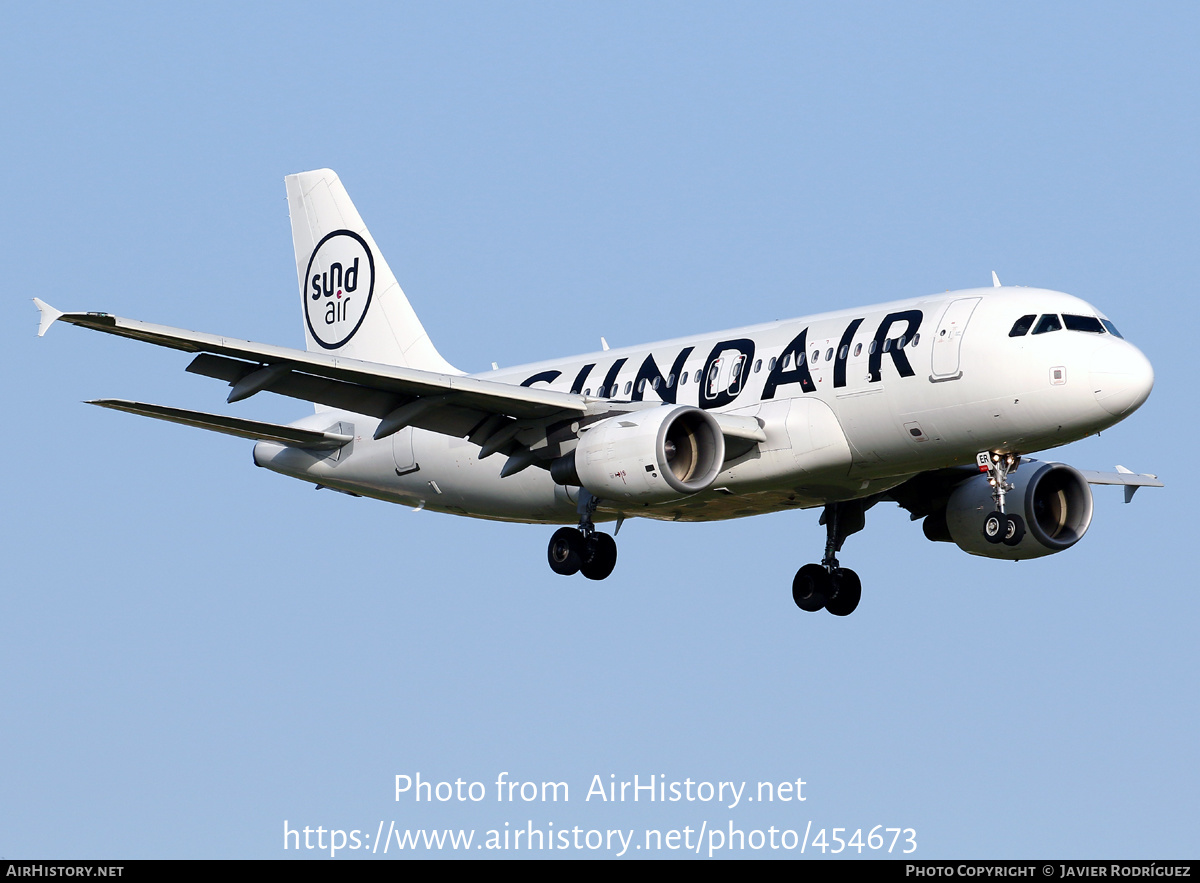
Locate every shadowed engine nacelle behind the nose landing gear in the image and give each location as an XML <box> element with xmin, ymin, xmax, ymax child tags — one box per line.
<box><xmin>925</xmin><ymin>461</ymin><xmax>1092</xmax><ymax>560</ymax></box>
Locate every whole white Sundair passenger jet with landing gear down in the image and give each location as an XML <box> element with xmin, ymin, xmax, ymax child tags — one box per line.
<box><xmin>35</xmin><ymin>169</ymin><xmax>1162</xmax><ymax>615</ymax></box>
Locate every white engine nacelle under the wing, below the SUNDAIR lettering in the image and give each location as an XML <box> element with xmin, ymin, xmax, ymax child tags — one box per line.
<box><xmin>551</xmin><ymin>404</ymin><xmax>725</xmax><ymax>504</ymax></box>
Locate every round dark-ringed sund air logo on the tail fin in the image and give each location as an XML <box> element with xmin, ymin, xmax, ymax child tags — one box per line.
<box><xmin>302</xmin><ymin>230</ymin><xmax>374</xmax><ymax>349</ymax></box>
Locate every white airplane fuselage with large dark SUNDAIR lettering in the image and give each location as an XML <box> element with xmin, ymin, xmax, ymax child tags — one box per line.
<box><xmin>254</xmin><ymin>288</ymin><xmax>1153</xmax><ymax>523</ymax></box>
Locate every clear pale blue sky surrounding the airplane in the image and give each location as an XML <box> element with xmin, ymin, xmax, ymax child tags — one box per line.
<box><xmin>0</xmin><ymin>4</ymin><xmax>1200</xmax><ymax>858</ymax></box>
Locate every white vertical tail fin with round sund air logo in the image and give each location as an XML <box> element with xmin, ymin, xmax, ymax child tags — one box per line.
<box><xmin>283</xmin><ymin>169</ymin><xmax>462</xmax><ymax>374</ymax></box>
